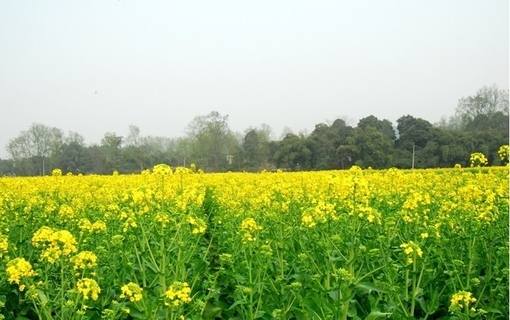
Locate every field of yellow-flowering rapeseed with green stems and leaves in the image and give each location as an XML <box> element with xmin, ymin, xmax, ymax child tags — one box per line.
<box><xmin>0</xmin><ymin>165</ymin><xmax>509</xmax><ymax>320</ymax></box>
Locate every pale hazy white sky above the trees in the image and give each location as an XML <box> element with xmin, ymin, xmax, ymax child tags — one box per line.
<box><xmin>0</xmin><ymin>0</ymin><xmax>509</xmax><ymax>158</ymax></box>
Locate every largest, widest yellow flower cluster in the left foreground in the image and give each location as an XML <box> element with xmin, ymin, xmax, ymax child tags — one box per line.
<box><xmin>32</xmin><ymin>226</ymin><xmax>78</xmax><ymax>263</ymax></box>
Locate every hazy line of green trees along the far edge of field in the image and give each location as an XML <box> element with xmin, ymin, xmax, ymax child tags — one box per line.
<box><xmin>0</xmin><ymin>85</ymin><xmax>509</xmax><ymax>175</ymax></box>
